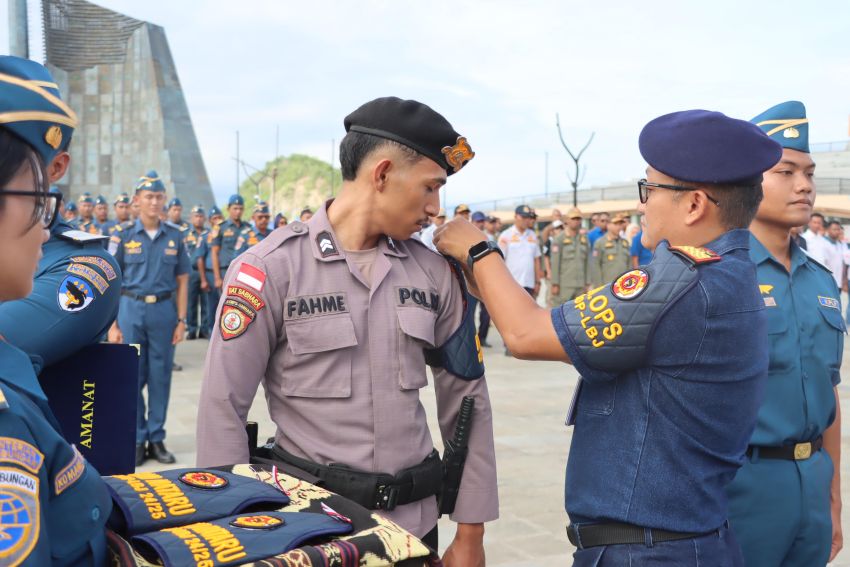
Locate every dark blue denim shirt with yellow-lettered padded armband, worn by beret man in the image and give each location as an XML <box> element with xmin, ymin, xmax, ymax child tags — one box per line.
<box><xmin>552</xmin><ymin>230</ymin><xmax>768</xmax><ymax>532</ymax></box>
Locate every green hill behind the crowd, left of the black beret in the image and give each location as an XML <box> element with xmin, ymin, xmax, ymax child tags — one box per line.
<box><xmin>239</xmin><ymin>154</ymin><xmax>342</xmax><ymax>220</ymax></box>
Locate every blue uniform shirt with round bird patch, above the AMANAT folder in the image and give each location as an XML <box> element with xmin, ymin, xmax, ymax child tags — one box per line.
<box><xmin>0</xmin><ymin>220</ymin><xmax>121</xmax><ymax>373</ymax></box>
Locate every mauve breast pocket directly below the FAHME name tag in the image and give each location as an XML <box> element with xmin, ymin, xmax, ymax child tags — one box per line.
<box><xmin>281</xmin><ymin>314</ymin><xmax>357</xmax><ymax>398</ymax></box>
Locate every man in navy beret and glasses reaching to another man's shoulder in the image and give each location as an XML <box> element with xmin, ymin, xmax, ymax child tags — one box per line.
<box><xmin>434</xmin><ymin>110</ymin><xmax>782</xmax><ymax>567</ymax></box>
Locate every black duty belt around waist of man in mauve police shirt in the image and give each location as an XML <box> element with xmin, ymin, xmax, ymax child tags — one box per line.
<box><xmin>272</xmin><ymin>445</ymin><xmax>443</xmax><ymax>511</ymax></box>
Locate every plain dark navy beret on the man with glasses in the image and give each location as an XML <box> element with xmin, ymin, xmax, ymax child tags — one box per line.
<box><xmin>639</xmin><ymin>110</ymin><xmax>782</xmax><ymax>184</ymax></box>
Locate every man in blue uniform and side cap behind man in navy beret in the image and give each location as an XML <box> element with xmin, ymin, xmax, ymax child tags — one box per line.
<box><xmin>728</xmin><ymin>101</ymin><xmax>845</xmax><ymax>567</ymax></box>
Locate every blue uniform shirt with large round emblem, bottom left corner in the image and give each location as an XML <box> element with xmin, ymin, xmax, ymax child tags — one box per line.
<box><xmin>0</xmin><ymin>341</ymin><xmax>112</xmax><ymax>567</ymax></box>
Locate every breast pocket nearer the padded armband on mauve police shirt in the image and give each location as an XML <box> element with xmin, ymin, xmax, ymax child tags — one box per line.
<box><xmin>396</xmin><ymin>307</ymin><xmax>437</xmax><ymax>390</ymax></box>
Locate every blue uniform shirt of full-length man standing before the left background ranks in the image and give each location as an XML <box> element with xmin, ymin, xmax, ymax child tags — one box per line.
<box><xmin>109</xmin><ymin>220</ymin><xmax>189</xmax><ymax>295</ymax></box>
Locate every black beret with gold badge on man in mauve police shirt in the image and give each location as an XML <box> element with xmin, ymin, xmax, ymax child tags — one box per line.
<box><xmin>344</xmin><ymin>96</ymin><xmax>475</xmax><ymax>175</ymax></box>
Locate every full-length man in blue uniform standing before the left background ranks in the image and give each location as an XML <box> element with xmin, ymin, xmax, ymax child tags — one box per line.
<box><xmin>109</xmin><ymin>171</ymin><xmax>189</xmax><ymax>466</ymax></box>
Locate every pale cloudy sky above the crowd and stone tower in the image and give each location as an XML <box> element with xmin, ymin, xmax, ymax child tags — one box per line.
<box><xmin>0</xmin><ymin>0</ymin><xmax>850</xmax><ymax>209</ymax></box>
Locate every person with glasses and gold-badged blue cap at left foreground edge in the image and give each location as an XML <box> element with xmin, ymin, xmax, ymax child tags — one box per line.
<box><xmin>0</xmin><ymin>58</ymin><xmax>112</xmax><ymax>566</ymax></box>
